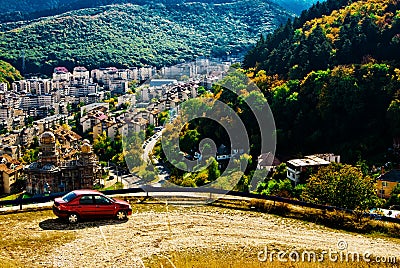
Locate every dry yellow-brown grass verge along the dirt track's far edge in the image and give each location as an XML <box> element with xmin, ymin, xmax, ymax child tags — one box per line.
<box><xmin>125</xmin><ymin>197</ymin><xmax>400</xmax><ymax>243</ymax></box>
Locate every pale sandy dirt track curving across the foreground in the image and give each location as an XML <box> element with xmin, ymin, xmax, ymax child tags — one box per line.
<box><xmin>31</xmin><ymin>207</ymin><xmax>400</xmax><ymax>267</ymax></box>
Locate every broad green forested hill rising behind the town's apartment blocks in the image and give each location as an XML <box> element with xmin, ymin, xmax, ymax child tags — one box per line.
<box><xmin>0</xmin><ymin>0</ymin><xmax>293</xmax><ymax>73</ymax></box>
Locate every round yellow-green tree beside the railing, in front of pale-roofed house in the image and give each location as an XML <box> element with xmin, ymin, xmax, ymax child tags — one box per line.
<box><xmin>302</xmin><ymin>163</ymin><xmax>379</xmax><ymax>210</ymax></box>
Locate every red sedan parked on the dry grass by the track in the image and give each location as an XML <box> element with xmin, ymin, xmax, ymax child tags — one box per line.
<box><xmin>53</xmin><ymin>190</ymin><xmax>132</xmax><ymax>223</ymax></box>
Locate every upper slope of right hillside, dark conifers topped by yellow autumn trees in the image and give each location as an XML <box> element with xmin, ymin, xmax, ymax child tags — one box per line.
<box><xmin>244</xmin><ymin>0</ymin><xmax>400</xmax><ymax>78</ymax></box>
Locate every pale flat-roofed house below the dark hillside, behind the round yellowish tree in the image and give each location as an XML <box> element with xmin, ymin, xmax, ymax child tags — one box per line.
<box><xmin>286</xmin><ymin>154</ymin><xmax>340</xmax><ymax>183</ymax></box>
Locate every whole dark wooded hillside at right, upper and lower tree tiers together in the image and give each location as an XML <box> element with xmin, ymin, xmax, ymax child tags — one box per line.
<box><xmin>244</xmin><ymin>0</ymin><xmax>400</xmax><ymax>162</ymax></box>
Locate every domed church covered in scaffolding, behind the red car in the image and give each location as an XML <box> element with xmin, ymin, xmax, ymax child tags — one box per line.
<box><xmin>24</xmin><ymin>131</ymin><xmax>102</xmax><ymax>194</ymax></box>
